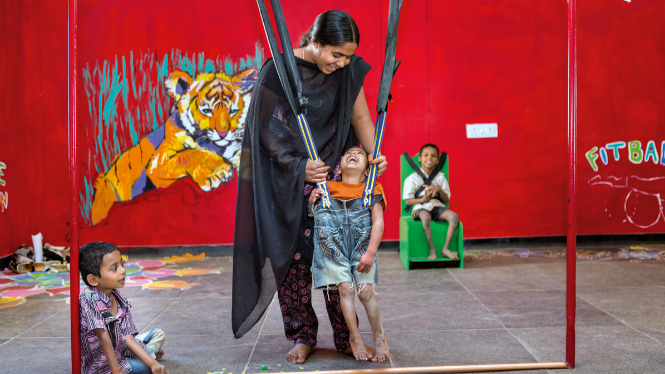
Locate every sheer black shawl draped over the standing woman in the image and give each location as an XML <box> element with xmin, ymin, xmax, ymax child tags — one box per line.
<box><xmin>232</xmin><ymin>56</ymin><xmax>371</xmax><ymax>338</ymax></box>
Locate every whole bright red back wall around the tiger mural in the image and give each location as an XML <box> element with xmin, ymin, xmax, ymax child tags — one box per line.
<box><xmin>0</xmin><ymin>0</ymin><xmax>665</xmax><ymax>252</ymax></box>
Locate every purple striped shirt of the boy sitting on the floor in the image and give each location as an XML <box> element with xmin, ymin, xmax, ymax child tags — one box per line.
<box><xmin>79</xmin><ymin>287</ymin><xmax>145</xmax><ymax>374</ymax></box>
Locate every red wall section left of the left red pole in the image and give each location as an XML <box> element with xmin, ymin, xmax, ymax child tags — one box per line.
<box><xmin>0</xmin><ymin>0</ymin><xmax>69</xmax><ymax>256</ymax></box>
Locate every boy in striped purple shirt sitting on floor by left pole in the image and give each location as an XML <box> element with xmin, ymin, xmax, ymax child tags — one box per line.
<box><xmin>79</xmin><ymin>242</ymin><xmax>169</xmax><ymax>374</ymax></box>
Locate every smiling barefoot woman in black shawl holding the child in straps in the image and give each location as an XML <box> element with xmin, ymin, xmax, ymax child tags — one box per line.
<box><xmin>232</xmin><ymin>10</ymin><xmax>387</xmax><ymax>363</ymax></box>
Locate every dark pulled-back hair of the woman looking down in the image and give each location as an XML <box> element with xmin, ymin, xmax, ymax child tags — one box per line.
<box><xmin>300</xmin><ymin>10</ymin><xmax>360</xmax><ymax>47</ymax></box>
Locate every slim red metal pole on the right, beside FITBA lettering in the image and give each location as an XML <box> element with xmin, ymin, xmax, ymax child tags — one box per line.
<box><xmin>566</xmin><ymin>0</ymin><xmax>577</xmax><ymax>369</ymax></box>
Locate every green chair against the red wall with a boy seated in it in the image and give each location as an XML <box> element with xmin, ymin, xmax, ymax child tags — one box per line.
<box><xmin>399</xmin><ymin>154</ymin><xmax>464</xmax><ymax>270</ymax></box>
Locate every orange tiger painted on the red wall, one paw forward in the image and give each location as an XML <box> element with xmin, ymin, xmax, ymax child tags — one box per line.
<box><xmin>91</xmin><ymin>68</ymin><xmax>258</xmax><ymax>225</ymax></box>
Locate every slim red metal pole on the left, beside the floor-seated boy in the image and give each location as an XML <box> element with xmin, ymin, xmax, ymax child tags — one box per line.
<box><xmin>68</xmin><ymin>0</ymin><xmax>81</xmax><ymax>374</ymax></box>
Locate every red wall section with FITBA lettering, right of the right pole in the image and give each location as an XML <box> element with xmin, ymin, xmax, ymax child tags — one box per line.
<box><xmin>578</xmin><ymin>0</ymin><xmax>665</xmax><ymax>234</ymax></box>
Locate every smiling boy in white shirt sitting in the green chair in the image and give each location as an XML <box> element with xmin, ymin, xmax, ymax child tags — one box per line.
<box><xmin>402</xmin><ymin>144</ymin><xmax>459</xmax><ymax>260</ymax></box>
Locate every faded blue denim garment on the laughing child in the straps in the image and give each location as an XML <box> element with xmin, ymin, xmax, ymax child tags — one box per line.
<box><xmin>312</xmin><ymin>199</ymin><xmax>379</xmax><ymax>289</ymax></box>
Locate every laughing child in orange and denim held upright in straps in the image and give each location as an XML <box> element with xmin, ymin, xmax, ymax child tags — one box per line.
<box><xmin>309</xmin><ymin>147</ymin><xmax>390</xmax><ymax>362</ymax></box>
